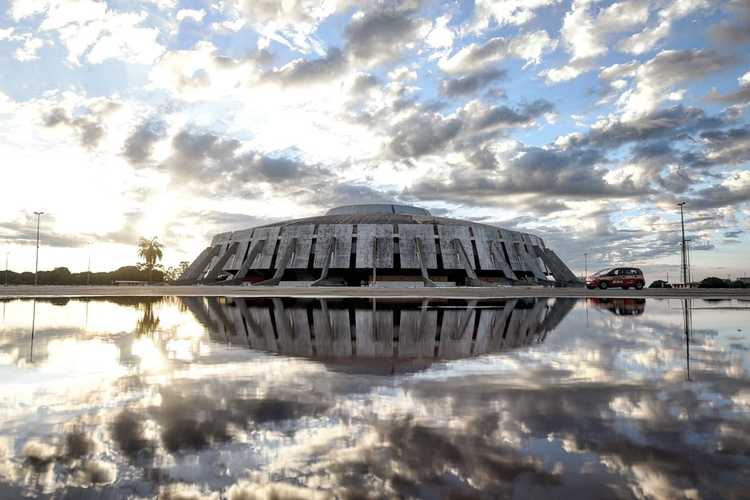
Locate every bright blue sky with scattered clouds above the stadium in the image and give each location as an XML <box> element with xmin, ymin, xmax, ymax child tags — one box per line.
<box><xmin>0</xmin><ymin>0</ymin><xmax>750</xmax><ymax>281</ymax></box>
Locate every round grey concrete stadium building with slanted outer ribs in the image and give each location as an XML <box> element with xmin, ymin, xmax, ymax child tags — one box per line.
<box><xmin>178</xmin><ymin>204</ymin><xmax>580</xmax><ymax>286</ymax></box>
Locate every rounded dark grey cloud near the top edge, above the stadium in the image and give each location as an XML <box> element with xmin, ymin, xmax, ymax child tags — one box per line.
<box><xmin>345</xmin><ymin>10</ymin><xmax>424</xmax><ymax>63</ymax></box>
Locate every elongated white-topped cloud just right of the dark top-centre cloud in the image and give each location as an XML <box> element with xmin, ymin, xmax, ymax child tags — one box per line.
<box><xmin>439</xmin><ymin>30</ymin><xmax>555</xmax><ymax>74</ymax></box>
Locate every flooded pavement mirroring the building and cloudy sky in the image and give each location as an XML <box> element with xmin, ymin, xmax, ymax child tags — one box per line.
<box><xmin>0</xmin><ymin>297</ymin><xmax>750</xmax><ymax>500</ymax></box>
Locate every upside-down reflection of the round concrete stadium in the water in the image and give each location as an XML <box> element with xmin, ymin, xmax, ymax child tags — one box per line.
<box><xmin>181</xmin><ymin>297</ymin><xmax>576</xmax><ymax>373</ymax></box>
